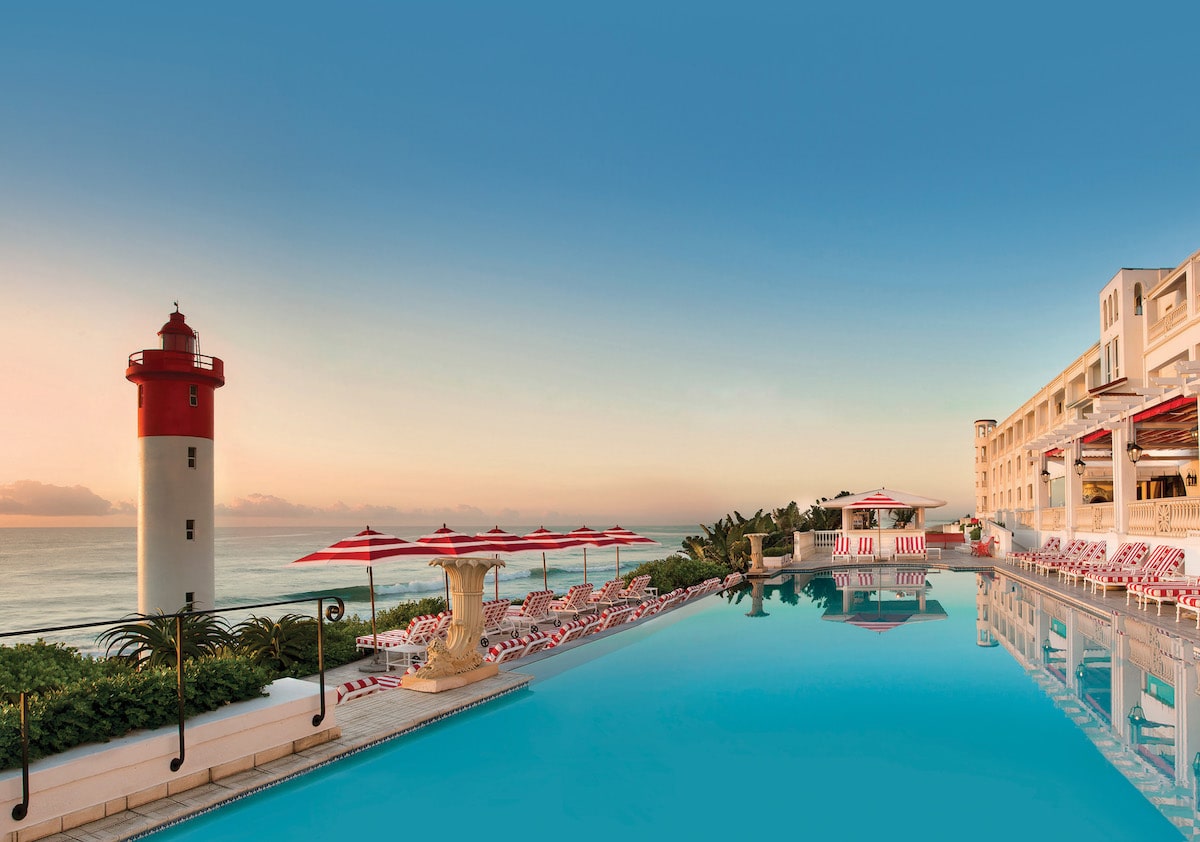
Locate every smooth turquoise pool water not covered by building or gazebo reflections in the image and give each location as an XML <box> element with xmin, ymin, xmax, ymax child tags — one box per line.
<box><xmin>149</xmin><ymin>573</ymin><xmax>1182</xmax><ymax>842</ymax></box>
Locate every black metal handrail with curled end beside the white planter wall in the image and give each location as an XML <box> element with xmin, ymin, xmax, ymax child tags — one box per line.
<box><xmin>0</xmin><ymin>596</ymin><xmax>346</xmax><ymax>822</ymax></box>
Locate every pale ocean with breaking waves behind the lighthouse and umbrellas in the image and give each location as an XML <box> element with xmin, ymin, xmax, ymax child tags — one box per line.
<box><xmin>0</xmin><ymin>524</ymin><xmax>701</xmax><ymax>652</ymax></box>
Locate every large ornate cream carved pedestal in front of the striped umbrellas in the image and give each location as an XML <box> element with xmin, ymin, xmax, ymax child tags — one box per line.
<box><xmin>401</xmin><ymin>555</ymin><xmax>504</xmax><ymax>693</ymax></box>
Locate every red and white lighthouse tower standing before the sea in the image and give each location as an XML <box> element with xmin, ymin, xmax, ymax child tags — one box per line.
<box><xmin>125</xmin><ymin>305</ymin><xmax>224</xmax><ymax>614</ymax></box>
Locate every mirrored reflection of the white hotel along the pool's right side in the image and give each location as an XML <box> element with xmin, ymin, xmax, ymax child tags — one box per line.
<box><xmin>976</xmin><ymin>571</ymin><xmax>1200</xmax><ymax>838</ymax></box>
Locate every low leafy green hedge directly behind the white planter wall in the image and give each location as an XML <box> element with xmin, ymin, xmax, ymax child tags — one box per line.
<box><xmin>0</xmin><ymin>656</ymin><xmax>271</xmax><ymax>769</ymax></box>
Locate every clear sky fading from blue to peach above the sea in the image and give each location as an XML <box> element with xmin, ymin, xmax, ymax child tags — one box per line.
<box><xmin>0</xmin><ymin>0</ymin><xmax>1200</xmax><ymax>527</ymax></box>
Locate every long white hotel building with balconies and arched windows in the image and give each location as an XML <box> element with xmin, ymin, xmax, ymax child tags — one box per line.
<box><xmin>974</xmin><ymin>252</ymin><xmax>1200</xmax><ymax>573</ymax></box>
